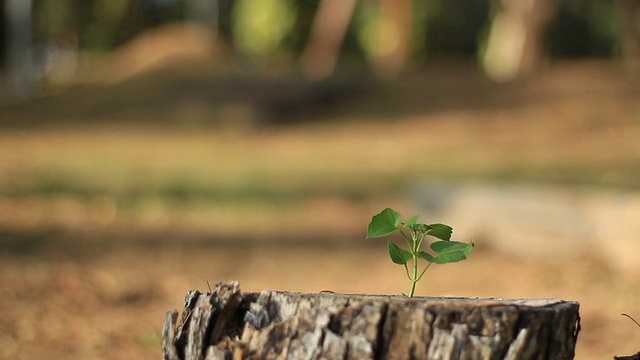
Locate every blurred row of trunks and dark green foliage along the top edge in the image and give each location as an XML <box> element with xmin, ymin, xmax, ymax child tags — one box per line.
<box><xmin>0</xmin><ymin>0</ymin><xmax>640</xmax><ymax>94</ymax></box>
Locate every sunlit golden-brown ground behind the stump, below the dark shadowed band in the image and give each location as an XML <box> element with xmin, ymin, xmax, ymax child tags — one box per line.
<box><xmin>0</xmin><ymin>63</ymin><xmax>640</xmax><ymax>360</ymax></box>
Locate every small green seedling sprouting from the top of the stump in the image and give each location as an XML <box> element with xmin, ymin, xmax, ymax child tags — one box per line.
<box><xmin>367</xmin><ymin>208</ymin><xmax>474</xmax><ymax>297</ymax></box>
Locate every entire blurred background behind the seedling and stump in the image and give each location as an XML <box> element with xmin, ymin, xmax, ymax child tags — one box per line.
<box><xmin>0</xmin><ymin>0</ymin><xmax>640</xmax><ymax>359</ymax></box>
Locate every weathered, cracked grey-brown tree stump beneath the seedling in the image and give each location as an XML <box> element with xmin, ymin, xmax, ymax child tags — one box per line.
<box><xmin>163</xmin><ymin>281</ymin><xmax>580</xmax><ymax>360</ymax></box>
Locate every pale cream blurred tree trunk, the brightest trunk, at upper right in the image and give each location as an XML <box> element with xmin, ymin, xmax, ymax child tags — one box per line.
<box><xmin>482</xmin><ymin>0</ymin><xmax>555</xmax><ymax>82</ymax></box>
